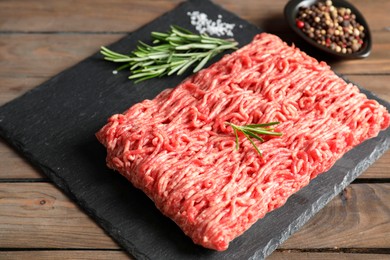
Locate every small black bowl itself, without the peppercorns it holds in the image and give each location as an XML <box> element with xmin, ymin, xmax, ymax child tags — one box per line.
<box><xmin>284</xmin><ymin>0</ymin><xmax>372</xmax><ymax>59</ymax></box>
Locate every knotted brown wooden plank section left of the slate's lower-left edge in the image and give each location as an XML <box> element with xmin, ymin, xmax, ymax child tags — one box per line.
<box><xmin>0</xmin><ymin>183</ymin><xmax>119</xmax><ymax>249</ymax></box>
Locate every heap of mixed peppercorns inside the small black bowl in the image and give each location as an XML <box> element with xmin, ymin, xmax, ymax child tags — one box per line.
<box><xmin>296</xmin><ymin>0</ymin><xmax>365</xmax><ymax>53</ymax></box>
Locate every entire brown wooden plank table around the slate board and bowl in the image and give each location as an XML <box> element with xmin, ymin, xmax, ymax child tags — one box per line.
<box><xmin>0</xmin><ymin>0</ymin><xmax>390</xmax><ymax>259</ymax></box>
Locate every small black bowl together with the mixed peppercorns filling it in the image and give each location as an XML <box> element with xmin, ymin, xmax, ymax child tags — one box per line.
<box><xmin>284</xmin><ymin>0</ymin><xmax>372</xmax><ymax>59</ymax></box>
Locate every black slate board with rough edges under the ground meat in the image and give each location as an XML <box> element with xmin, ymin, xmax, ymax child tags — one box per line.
<box><xmin>0</xmin><ymin>0</ymin><xmax>390</xmax><ymax>259</ymax></box>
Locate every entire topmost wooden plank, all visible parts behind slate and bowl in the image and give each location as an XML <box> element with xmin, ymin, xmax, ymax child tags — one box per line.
<box><xmin>0</xmin><ymin>0</ymin><xmax>390</xmax><ymax>32</ymax></box>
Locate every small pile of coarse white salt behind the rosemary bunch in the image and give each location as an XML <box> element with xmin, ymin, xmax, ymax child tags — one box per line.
<box><xmin>187</xmin><ymin>11</ymin><xmax>235</xmax><ymax>37</ymax></box>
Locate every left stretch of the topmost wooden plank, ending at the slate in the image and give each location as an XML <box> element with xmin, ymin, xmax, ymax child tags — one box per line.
<box><xmin>0</xmin><ymin>0</ymin><xmax>182</xmax><ymax>32</ymax></box>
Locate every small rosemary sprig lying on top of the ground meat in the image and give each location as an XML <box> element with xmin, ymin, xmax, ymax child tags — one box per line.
<box><xmin>226</xmin><ymin>122</ymin><xmax>283</xmax><ymax>156</ymax></box>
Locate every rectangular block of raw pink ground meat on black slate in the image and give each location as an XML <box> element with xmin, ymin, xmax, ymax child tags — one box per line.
<box><xmin>97</xmin><ymin>33</ymin><xmax>390</xmax><ymax>250</ymax></box>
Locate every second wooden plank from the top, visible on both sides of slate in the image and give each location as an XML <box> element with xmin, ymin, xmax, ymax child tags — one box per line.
<box><xmin>0</xmin><ymin>32</ymin><xmax>390</xmax><ymax>84</ymax></box>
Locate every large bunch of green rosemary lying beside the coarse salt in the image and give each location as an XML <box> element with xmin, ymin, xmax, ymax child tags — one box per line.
<box><xmin>100</xmin><ymin>26</ymin><xmax>238</xmax><ymax>82</ymax></box>
